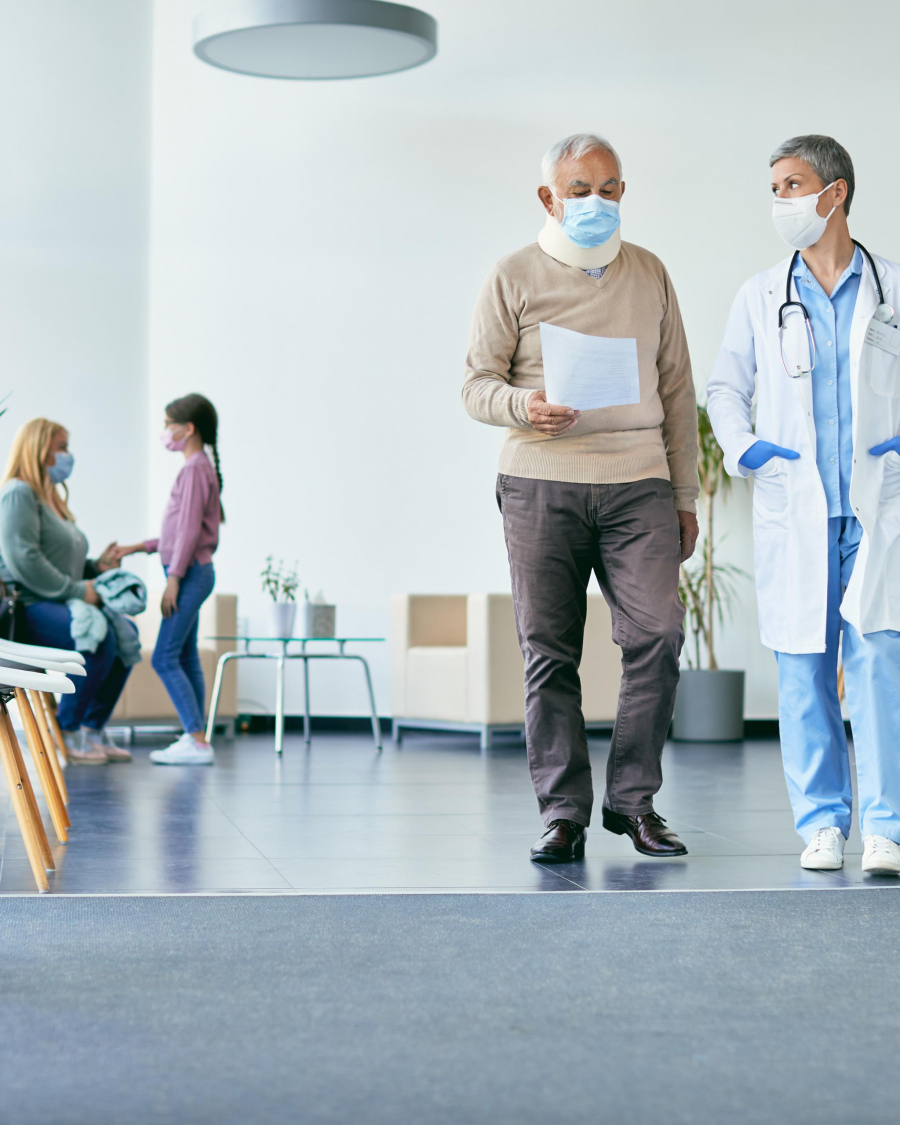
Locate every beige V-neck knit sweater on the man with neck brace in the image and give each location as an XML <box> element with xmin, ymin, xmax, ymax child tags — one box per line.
<box><xmin>462</xmin><ymin>242</ymin><xmax>700</xmax><ymax>512</ymax></box>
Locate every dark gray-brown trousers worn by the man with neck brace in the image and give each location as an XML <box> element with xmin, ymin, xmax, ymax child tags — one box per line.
<box><xmin>497</xmin><ymin>475</ymin><xmax>684</xmax><ymax>825</ymax></box>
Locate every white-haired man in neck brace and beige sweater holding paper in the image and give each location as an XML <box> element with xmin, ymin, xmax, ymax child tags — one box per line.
<box><xmin>462</xmin><ymin>134</ymin><xmax>700</xmax><ymax>863</ymax></box>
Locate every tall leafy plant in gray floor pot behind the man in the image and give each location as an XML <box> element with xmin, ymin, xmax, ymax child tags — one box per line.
<box><xmin>672</xmin><ymin>405</ymin><xmax>746</xmax><ymax>743</ymax></box>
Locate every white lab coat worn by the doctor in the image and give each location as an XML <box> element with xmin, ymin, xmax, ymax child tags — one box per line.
<box><xmin>707</xmin><ymin>254</ymin><xmax>900</xmax><ymax>653</ymax></box>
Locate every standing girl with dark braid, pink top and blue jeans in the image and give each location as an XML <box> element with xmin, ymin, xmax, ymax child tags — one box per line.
<box><xmin>117</xmin><ymin>395</ymin><xmax>225</xmax><ymax>766</ymax></box>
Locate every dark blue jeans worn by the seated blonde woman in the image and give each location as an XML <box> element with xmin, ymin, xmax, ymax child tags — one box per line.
<box><xmin>25</xmin><ymin>602</ymin><xmax>132</xmax><ymax>730</ymax></box>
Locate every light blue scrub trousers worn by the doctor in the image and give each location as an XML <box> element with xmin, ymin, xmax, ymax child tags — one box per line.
<box><xmin>775</xmin><ymin>516</ymin><xmax>900</xmax><ymax>844</ymax></box>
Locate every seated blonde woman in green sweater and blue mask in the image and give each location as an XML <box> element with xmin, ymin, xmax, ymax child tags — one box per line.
<box><xmin>0</xmin><ymin>419</ymin><xmax>132</xmax><ymax>765</ymax></box>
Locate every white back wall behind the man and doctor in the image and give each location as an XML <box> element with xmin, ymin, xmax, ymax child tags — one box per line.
<box><xmin>145</xmin><ymin>0</ymin><xmax>900</xmax><ymax>716</ymax></box>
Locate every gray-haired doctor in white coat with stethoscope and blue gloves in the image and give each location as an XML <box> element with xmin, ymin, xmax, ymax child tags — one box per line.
<box><xmin>708</xmin><ymin>136</ymin><xmax>900</xmax><ymax>874</ymax></box>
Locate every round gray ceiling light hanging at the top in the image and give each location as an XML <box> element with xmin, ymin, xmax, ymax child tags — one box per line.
<box><xmin>194</xmin><ymin>0</ymin><xmax>438</xmax><ymax>80</ymax></box>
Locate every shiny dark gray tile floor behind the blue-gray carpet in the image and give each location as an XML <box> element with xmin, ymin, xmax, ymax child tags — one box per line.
<box><xmin>0</xmin><ymin>734</ymin><xmax>898</xmax><ymax>894</ymax></box>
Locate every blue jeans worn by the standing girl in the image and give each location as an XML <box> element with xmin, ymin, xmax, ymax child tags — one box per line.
<box><xmin>153</xmin><ymin>563</ymin><xmax>216</xmax><ymax>731</ymax></box>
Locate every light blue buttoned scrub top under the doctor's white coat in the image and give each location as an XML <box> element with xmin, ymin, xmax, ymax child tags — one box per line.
<box><xmin>793</xmin><ymin>246</ymin><xmax>863</xmax><ymax>518</ymax></box>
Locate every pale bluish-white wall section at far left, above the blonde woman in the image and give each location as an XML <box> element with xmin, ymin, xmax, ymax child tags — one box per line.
<box><xmin>0</xmin><ymin>0</ymin><xmax>151</xmax><ymax>560</ymax></box>
